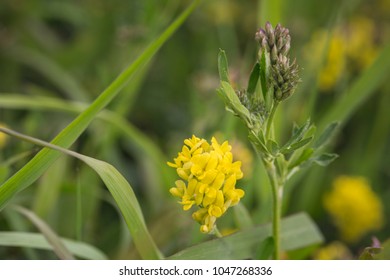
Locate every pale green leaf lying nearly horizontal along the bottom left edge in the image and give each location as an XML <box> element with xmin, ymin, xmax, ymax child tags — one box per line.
<box><xmin>0</xmin><ymin>231</ymin><xmax>107</xmax><ymax>260</ymax></box>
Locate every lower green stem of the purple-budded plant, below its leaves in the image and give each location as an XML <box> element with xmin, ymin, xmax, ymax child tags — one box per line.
<box><xmin>263</xmin><ymin>159</ymin><xmax>283</xmax><ymax>260</ymax></box>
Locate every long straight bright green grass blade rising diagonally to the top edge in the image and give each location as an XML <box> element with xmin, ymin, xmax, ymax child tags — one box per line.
<box><xmin>0</xmin><ymin>0</ymin><xmax>200</xmax><ymax>209</ymax></box>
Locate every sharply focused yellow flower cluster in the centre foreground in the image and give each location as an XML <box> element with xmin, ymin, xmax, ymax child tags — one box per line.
<box><xmin>168</xmin><ymin>135</ymin><xmax>244</xmax><ymax>233</ymax></box>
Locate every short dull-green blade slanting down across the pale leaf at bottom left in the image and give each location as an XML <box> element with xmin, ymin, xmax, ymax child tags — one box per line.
<box><xmin>12</xmin><ymin>205</ymin><xmax>74</xmax><ymax>260</ymax></box>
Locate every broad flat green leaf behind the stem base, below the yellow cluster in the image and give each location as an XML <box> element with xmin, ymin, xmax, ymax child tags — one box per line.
<box><xmin>168</xmin><ymin>213</ymin><xmax>323</xmax><ymax>260</ymax></box>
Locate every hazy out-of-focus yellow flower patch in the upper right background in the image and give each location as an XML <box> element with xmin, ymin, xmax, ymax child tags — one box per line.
<box><xmin>305</xmin><ymin>16</ymin><xmax>378</xmax><ymax>92</ymax></box>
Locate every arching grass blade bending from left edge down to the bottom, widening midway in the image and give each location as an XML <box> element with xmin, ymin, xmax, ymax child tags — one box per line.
<box><xmin>0</xmin><ymin>127</ymin><xmax>162</xmax><ymax>259</ymax></box>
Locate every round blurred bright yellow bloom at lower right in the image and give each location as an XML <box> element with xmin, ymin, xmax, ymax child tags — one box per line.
<box><xmin>324</xmin><ymin>176</ymin><xmax>383</xmax><ymax>242</ymax></box>
